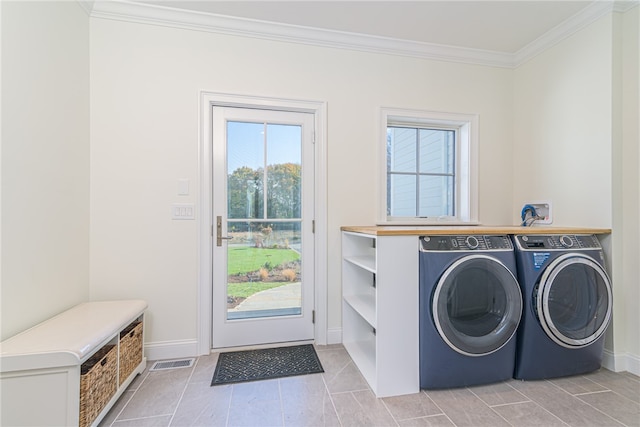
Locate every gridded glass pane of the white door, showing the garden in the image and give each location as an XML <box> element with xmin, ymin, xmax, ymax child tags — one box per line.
<box><xmin>226</xmin><ymin>121</ymin><xmax>302</xmax><ymax>320</ymax></box>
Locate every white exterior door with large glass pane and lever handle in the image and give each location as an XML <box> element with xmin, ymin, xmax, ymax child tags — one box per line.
<box><xmin>212</xmin><ymin>107</ymin><xmax>314</xmax><ymax>348</ymax></box>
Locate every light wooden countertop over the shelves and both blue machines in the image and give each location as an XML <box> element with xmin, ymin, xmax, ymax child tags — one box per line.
<box><xmin>340</xmin><ymin>225</ymin><xmax>611</xmax><ymax>236</ymax></box>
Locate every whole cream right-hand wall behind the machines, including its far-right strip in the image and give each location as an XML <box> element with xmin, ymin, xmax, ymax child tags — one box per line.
<box><xmin>513</xmin><ymin>7</ymin><xmax>640</xmax><ymax>373</ymax></box>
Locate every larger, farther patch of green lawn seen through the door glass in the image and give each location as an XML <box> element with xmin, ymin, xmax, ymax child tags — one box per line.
<box><xmin>227</xmin><ymin>246</ymin><xmax>300</xmax><ymax>276</ymax></box>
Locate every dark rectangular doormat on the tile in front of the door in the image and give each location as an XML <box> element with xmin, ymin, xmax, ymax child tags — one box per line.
<box><xmin>211</xmin><ymin>344</ymin><xmax>324</xmax><ymax>386</ymax></box>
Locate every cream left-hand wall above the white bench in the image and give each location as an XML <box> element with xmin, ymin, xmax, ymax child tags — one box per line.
<box><xmin>0</xmin><ymin>1</ymin><xmax>89</xmax><ymax>339</ymax></box>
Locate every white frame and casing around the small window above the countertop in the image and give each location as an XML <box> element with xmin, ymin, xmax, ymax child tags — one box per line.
<box><xmin>378</xmin><ymin>107</ymin><xmax>478</xmax><ymax>225</ymax></box>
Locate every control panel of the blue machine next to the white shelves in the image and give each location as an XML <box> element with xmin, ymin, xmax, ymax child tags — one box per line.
<box><xmin>420</xmin><ymin>234</ymin><xmax>513</xmax><ymax>251</ymax></box>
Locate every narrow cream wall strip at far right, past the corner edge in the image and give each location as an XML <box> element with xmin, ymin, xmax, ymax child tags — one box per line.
<box><xmin>612</xmin><ymin>6</ymin><xmax>640</xmax><ymax>375</ymax></box>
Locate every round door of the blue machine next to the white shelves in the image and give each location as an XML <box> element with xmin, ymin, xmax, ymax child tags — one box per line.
<box><xmin>431</xmin><ymin>254</ymin><xmax>522</xmax><ymax>356</ymax></box>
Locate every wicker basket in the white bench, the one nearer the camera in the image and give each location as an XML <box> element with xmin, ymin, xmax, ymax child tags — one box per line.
<box><xmin>79</xmin><ymin>345</ymin><xmax>118</xmax><ymax>427</ymax></box>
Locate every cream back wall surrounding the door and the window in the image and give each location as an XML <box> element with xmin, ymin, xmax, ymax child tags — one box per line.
<box><xmin>91</xmin><ymin>15</ymin><xmax>513</xmax><ymax>352</ymax></box>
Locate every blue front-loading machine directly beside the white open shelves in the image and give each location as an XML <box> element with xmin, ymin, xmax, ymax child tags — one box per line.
<box><xmin>419</xmin><ymin>235</ymin><xmax>522</xmax><ymax>389</ymax></box>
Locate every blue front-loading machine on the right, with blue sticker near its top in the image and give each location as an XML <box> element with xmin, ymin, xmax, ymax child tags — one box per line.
<box><xmin>513</xmin><ymin>234</ymin><xmax>612</xmax><ymax>380</ymax></box>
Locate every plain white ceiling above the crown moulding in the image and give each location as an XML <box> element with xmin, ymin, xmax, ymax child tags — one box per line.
<box><xmin>138</xmin><ymin>0</ymin><xmax>600</xmax><ymax>54</ymax></box>
